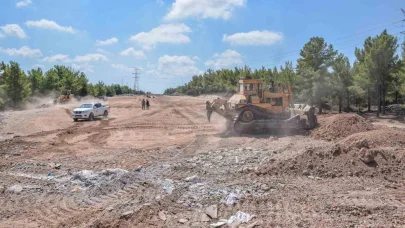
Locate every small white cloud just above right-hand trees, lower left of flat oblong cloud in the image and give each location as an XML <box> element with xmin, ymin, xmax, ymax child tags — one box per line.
<box><xmin>205</xmin><ymin>49</ymin><xmax>243</xmax><ymax>69</ymax></box>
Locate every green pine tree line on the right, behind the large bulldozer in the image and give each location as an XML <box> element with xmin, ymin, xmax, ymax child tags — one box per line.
<box><xmin>164</xmin><ymin>30</ymin><xmax>405</xmax><ymax>114</ymax></box>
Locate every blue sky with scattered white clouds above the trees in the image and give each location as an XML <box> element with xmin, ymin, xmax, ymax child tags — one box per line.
<box><xmin>0</xmin><ymin>0</ymin><xmax>405</xmax><ymax>93</ymax></box>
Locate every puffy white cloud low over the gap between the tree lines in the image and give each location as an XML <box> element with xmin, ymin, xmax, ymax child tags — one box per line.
<box><xmin>147</xmin><ymin>55</ymin><xmax>202</xmax><ymax>78</ymax></box>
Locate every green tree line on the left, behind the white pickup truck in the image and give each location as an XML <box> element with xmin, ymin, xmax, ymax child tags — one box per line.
<box><xmin>0</xmin><ymin>61</ymin><xmax>144</xmax><ymax>109</ymax></box>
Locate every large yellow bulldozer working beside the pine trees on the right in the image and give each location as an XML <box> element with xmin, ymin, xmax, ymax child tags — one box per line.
<box><xmin>206</xmin><ymin>79</ymin><xmax>317</xmax><ymax>133</ymax></box>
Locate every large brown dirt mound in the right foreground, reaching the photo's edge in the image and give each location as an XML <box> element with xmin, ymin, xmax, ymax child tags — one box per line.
<box><xmin>256</xmin><ymin>127</ymin><xmax>405</xmax><ymax>179</ymax></box>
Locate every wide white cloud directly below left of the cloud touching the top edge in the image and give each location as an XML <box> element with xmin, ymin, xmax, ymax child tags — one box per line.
<box><xmin>129</xmin><ymin>24</ymin><xmax>192</xmax><ymax>50</ymax></box>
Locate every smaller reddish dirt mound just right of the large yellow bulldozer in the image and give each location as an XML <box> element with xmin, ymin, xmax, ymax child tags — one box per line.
<box><xmin>311</xmin><ymin>114</ymin><xmax>375</xmax><ymax>141</ymax></box>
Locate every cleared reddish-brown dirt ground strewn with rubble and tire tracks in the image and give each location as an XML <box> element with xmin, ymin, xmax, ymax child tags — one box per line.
<box><xmin>0</xmin><ymin>96</ymin><xmax>405</xmax><ymax>227</ymax></box>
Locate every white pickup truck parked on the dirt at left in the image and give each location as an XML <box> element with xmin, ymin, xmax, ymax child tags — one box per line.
<box><xmin>72</xmin><ymin>103</ymin><xmax>110</xmax><ymax>121</ymax></box>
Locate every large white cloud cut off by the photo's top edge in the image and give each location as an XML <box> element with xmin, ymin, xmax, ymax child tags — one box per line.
<box><xmin>165</xmin><ymin>0</ymin><xmax>247</xmax><ymax>20</ymax></box>
